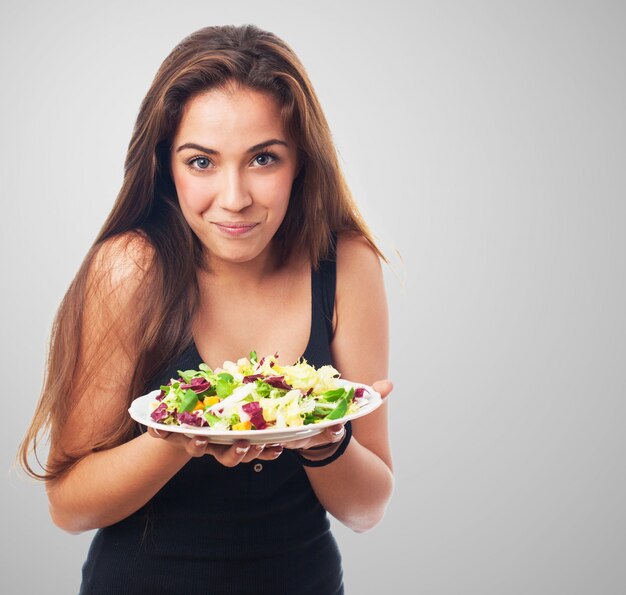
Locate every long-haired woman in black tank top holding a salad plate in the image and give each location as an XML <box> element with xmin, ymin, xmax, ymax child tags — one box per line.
<box><xmin>21</xmin><ymin>26</ymin><xmax>393</xmax><ymax>595</ymax></box>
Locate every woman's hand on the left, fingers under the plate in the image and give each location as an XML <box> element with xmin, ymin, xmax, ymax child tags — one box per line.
<box><xmin>148</xmin><ymin>428</ymin><xmax>283</xmax><ymax>467</ymax></box>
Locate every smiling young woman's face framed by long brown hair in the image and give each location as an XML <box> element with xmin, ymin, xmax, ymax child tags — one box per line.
<box><xmin>171</xmin><ymin>87</ymin><xmax>297</xmax><ymax>263</ymax></box>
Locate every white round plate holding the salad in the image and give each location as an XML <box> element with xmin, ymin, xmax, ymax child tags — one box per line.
<box><xmin>128</xmin><ymin>380</ymin><xmax>382</xmax><ymax>444</ymax></box>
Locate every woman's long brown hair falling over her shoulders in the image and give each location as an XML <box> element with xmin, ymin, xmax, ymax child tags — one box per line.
<box><xmin>18</xmin><ymin>25</ymin><xmax>384</xmax><ymax>480</ymax></box>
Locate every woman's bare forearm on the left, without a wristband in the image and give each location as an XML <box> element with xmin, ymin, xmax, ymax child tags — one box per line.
<box><xmin>48</xmin><ymin>434</ymin><xmax>190</xmax><ymax>533</ymax></box>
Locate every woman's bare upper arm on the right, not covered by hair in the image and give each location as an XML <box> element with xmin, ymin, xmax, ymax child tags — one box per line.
<box><xmin>331</xmin><ymin>234</ymin><xmax>391</xmax><ymax>468</ymax></box>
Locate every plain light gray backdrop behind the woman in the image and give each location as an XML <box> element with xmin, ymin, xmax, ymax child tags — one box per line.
<box><xmin>0</xmin><ymin>0</ymin><xmax>626</xmax><ymax>595</ymax></box>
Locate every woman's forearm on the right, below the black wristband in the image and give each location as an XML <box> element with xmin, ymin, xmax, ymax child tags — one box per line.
<box><xmin>305</xmin><ymin>437</ymin><xmax>393</xmax><ymax>532</ymax></box>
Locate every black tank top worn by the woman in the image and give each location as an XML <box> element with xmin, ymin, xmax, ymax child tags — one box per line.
<box><xmin>80</xmin><ymin>260</ymin><xmax>343</xmax><ymax>595</ymax></box>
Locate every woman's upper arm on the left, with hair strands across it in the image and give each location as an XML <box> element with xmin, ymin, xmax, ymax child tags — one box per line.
<box><xmin>52</xmin><ymin>233</ymin><xmax>152</xmax><ymax>457</ymax></box>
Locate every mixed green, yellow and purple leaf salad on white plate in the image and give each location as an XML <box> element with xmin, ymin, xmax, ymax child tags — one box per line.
<box><xmin>150</xmin><ymin>351</ymin><xmax>367</xmax><ymax>431</ymax></box>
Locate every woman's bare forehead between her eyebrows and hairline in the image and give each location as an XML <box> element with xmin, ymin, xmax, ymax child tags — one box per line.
<box><xmin>175</xmin><ymin>87</ymin><xmax>287</xmax><ymax>150</ymax></box>
